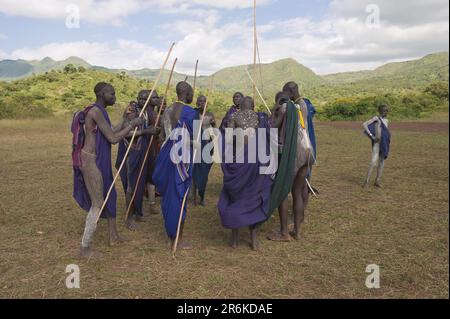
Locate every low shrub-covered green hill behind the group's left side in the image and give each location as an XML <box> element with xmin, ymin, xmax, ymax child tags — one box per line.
<box><xmin>0</xmin><ymin>68</ymin><xmax>231</xmax><ymax>119</ymax></box>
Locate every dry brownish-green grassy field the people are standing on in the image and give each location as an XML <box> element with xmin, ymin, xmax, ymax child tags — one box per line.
<box><xmin>0</xmin><ymin>119</ymin><xmax>449</xmax><ymax>298</ymax></box>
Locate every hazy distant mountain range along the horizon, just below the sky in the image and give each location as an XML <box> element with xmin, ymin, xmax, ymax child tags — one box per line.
<box><xmin>0</xmin><ymin>52</ymin><xmax>449</xmax><ymax>96</ymax></box>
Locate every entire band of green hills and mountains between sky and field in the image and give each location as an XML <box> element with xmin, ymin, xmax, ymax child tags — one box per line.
<box><xmin>0</xmin><ymin>52</ymin><xmax>449</xmax><ymax>119</ymax></box>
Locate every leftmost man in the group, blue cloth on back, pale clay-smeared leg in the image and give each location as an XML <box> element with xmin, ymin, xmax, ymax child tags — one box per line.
<box><xmin>72</xmin><ymin>82</ymin><xmax>143</xmax><ymax>258</ymax></box>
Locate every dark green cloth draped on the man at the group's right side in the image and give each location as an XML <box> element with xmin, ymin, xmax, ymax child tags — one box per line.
<box><xmin>269</xmin><ymin>101</ymin><xmax>299</xmax><ymax>214</ymax></box>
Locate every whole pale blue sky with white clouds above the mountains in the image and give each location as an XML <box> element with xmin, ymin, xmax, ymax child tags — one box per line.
<box><xmin>0</xmin><ymin>0</ymin><xmax>449</xmax><ymax>74</ymax></box>
